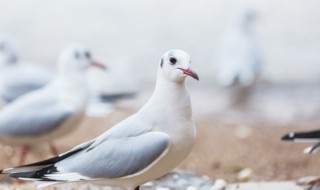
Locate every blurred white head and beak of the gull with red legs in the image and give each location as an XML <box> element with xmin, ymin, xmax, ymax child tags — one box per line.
<box><xmin>58</xmin><ymin>44</ymin><xmax>106</xmax><ymax>72</ymax></box>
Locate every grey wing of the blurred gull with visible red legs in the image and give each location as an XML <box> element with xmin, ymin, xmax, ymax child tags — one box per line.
<box><xmin>0</xmin><ymin>93</ymin><xmax>73</xmax><ymax>137</ymax></box>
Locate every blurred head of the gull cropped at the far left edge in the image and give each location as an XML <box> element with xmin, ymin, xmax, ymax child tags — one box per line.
<box><xmin>0</xmin><ymin>36</ymin><xmax>17</xmax><ymax>65</ymax></box>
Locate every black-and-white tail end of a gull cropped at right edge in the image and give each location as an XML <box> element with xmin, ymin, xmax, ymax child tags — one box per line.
<box><xmin>281</xmin><ymin>130</ymin><xmax>320</xmax><ymax>154</ymax></box>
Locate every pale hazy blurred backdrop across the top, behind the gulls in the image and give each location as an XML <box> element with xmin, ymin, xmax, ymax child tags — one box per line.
<box><xmin>0</xmin><ymin>0</ymin><xmax>320</xmax><ymax>84</ymax></box>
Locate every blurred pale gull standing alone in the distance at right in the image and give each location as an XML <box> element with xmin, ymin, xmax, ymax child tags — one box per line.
<box><xmin>217</xmin><ymin>9</ymin><xmax>262</xmax><ymax>105</ymax></box>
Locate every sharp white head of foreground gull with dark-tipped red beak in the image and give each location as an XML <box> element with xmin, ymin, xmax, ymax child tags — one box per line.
<box><xmin>159</xmin><ymin>49</ymin><xmax>199</xmax><ymax>82</ymax></box>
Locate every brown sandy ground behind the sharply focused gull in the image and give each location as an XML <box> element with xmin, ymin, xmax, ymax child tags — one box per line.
<box><xmin>0</xmin><ymin>110</ymin><xmax>320</xmax><ymax>185</ymax></box>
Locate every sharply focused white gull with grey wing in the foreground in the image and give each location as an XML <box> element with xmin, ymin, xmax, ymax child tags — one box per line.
<box><xmin>0</xmin><ymin>50</ymin><xmax>199</xmax><ymax>190</ymax></box>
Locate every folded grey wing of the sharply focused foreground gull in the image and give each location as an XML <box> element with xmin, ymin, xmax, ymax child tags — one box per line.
<box><xmin>52</xmin><ymin>132</ymin><xmax>169</xmax><ymax>180</ymax></box>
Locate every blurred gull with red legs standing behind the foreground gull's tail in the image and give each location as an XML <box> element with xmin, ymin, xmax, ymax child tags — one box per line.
<box><xmin>0</xmin><ymin>44</ymin><xmax>104</xmax><ymax>164</ymax></box>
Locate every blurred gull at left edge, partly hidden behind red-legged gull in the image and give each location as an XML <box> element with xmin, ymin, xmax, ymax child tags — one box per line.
<box><xmin>0</xmin><ymin>35</ymin><xmax>54</xmax><ymax>103</ymax></box>
